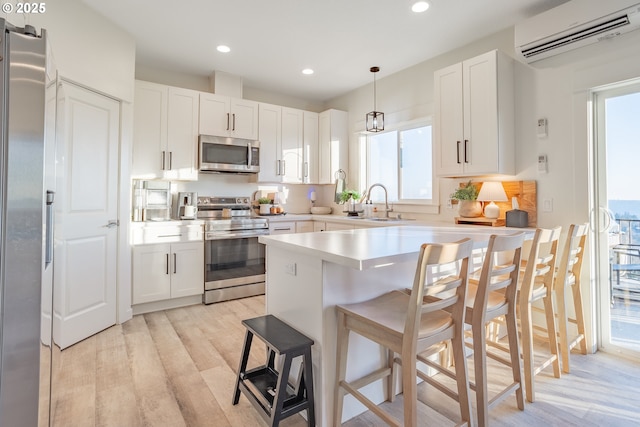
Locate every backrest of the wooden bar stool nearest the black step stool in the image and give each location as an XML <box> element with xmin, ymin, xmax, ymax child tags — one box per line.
<box><xmin>404</xmin><ymin>238</ymin><xmax>473</xmax><ymax>351</ymax></box>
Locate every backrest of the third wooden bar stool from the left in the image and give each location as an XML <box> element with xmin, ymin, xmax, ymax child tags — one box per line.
<box><xmin>520</xmin><ymin>227</ymin><xmax>562</xmax><ymax>304</ymax></box>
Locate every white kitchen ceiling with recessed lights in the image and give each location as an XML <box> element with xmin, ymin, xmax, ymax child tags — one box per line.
<box><xmin>83</xmin><ymin>0</ymin><xmax>566</xmax><ymax>102</ymax></box>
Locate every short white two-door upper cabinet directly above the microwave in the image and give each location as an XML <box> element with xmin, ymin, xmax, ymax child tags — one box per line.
<box><xmin>199</xmin><ymin>93</ymin><xmax>258</xmax><ymax>139</ymax></box>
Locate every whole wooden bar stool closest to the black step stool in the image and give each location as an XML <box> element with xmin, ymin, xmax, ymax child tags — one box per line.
<box><xmin>333</xmin><ymin>239</ymin><xmax>472</xmax><ymax>427</ymax></box>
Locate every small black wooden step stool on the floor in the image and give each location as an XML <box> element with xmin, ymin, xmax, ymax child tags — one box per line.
<box><xmin>233</xmin><ymin>314</ymin><xmax>316</xmax><ymax>427</ymax></box>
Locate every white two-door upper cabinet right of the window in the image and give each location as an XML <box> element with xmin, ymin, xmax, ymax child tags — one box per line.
<box><xmin>433</xmin><ymin>50</ymin><xmax>515</xmax><ymax>176</ymax></box>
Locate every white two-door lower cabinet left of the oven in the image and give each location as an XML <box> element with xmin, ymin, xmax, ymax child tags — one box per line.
<box><xmin>132</xmin><ymin>241</ymin><xmax>204</xmax><ymax>304</ymax></box>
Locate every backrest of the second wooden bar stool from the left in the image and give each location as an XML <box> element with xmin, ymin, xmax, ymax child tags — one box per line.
<box><xmin>467</xmin><ymin>232</ymin><xmax>524</xmax><ymax>325</ymax></box>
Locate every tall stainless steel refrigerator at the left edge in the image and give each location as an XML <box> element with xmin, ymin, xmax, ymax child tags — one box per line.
<box><xmin>0</xmin><ymin>19</ymin><xmax>55</xmax><ymax>427</ymax></box>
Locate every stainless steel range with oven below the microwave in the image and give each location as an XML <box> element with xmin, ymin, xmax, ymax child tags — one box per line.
<box><xmin>198</xmin><ymin>197</ymin><xmax>269</xmax><ymax>304</ymax></box>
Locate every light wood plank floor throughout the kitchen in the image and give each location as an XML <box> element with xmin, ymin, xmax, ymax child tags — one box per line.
<box><xmin>52</xmin><ymin>297</ymin><xmax>640</xmax><ymax>427</ymax></box>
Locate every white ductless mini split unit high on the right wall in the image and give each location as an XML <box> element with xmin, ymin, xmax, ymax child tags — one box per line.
<box><xmin>515</xmin><ymin>0</ymin><xmax>640</xmax><ymax>63</ymax></box>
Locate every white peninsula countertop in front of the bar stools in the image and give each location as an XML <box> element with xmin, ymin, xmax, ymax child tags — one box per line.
<box><xmin>259</xmin><ymin>226</ymin><xmax>533</xmax><ymax>270</ymax></box>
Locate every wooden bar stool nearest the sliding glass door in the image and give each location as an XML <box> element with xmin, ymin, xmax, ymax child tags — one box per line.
<box><xmin>555</xmin><ymin>223</ymin><xmax>589</xmax><ymax>373</ymax></box>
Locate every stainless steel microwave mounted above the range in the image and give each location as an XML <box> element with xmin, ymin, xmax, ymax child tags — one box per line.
<box><xmin>198</xmin><ymin>135</ymin><xmax>260</xmax><ymax>173</ymax></box>
